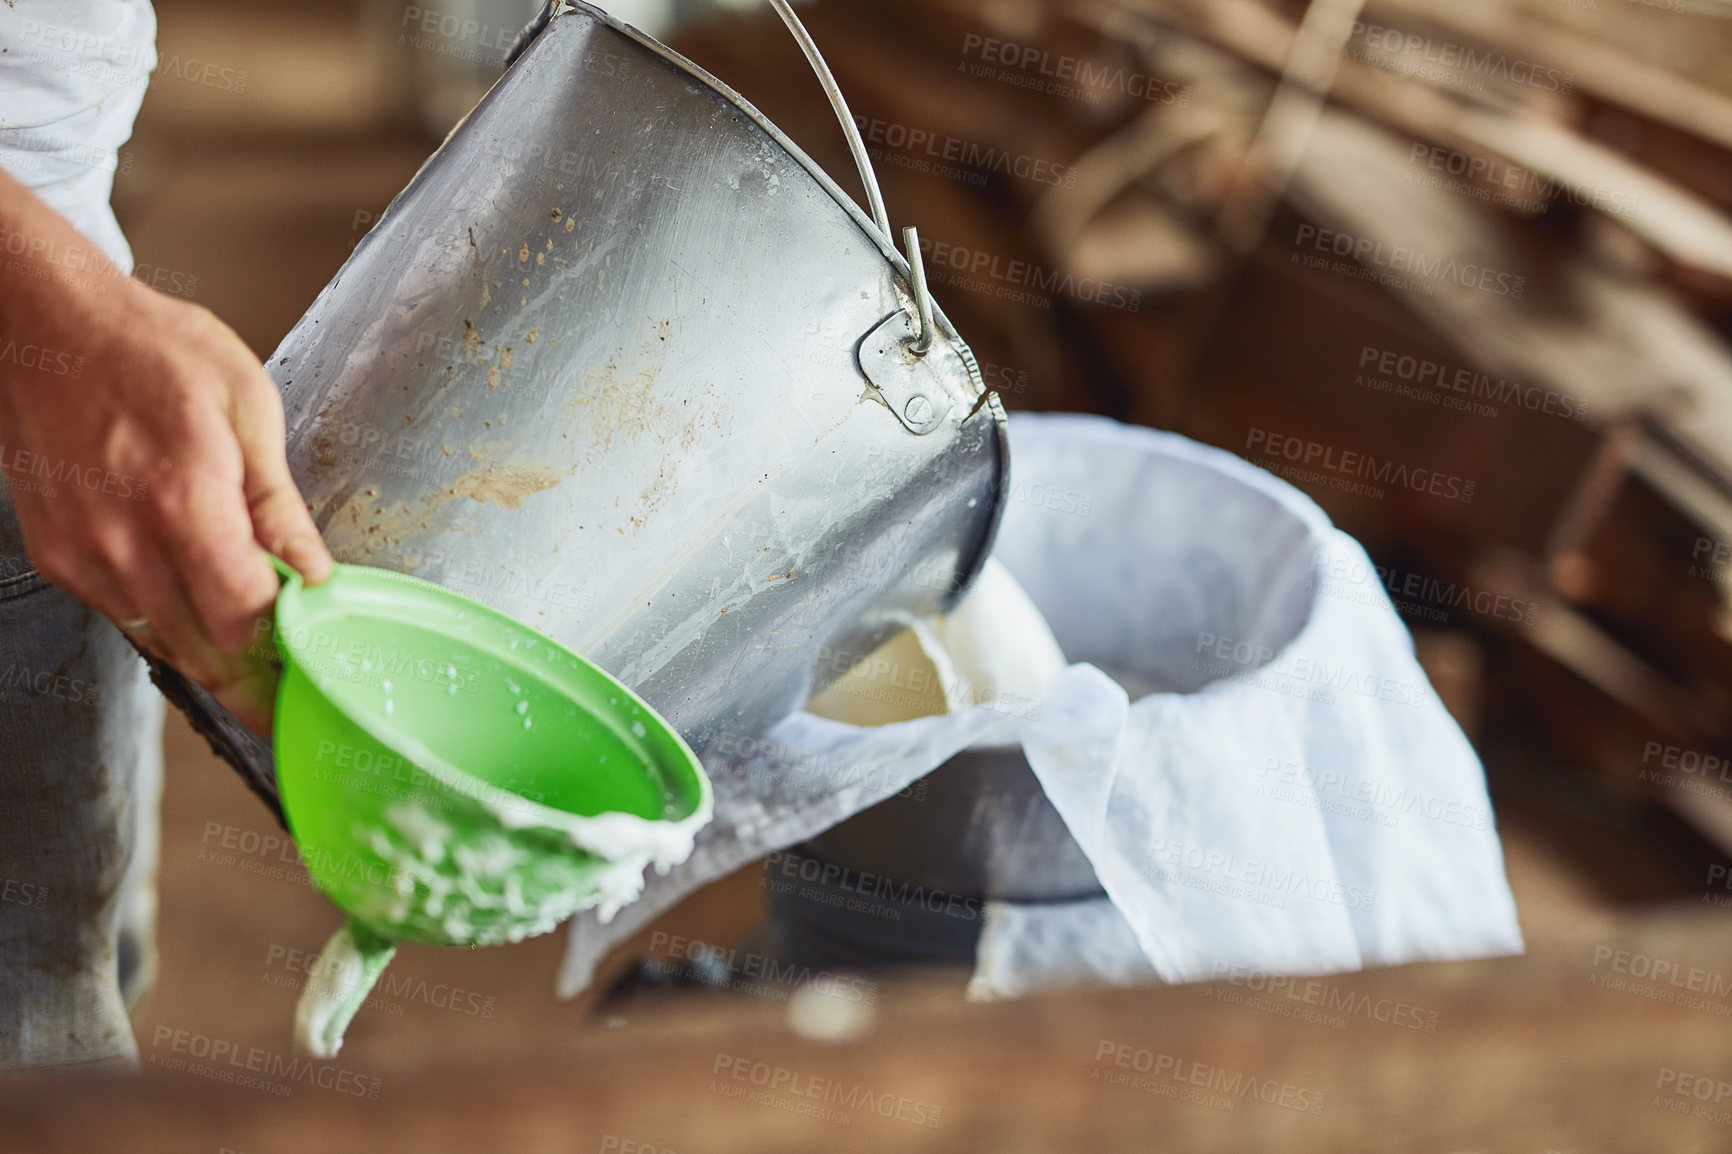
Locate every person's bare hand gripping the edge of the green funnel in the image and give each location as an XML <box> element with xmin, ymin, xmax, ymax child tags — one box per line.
<box><xmin>0</xmin><ymin>175</ymin><xmax>331</xmax><ymax>733</ymax></box>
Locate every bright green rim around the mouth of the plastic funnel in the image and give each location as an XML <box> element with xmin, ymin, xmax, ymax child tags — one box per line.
<box><xmin>272</xmin><ymin>558</ymin><xmax>714</xmax><ymax>833</ymax></box>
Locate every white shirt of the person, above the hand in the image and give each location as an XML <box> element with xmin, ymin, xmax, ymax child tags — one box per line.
<box><xmin>0</xmin><ymin>0</ymin><xmax>156</xmax><ymax>270</ymax></box>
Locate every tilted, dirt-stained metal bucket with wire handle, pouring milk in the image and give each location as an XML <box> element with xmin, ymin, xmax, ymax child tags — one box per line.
<box><xmin>158</xmin><ymin>0</ymin><xmax>1008</xmax><ymax>801</ymax></box>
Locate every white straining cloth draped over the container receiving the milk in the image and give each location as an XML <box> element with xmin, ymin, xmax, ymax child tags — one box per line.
<box><xmin>561</xmin><ymin>414</ymin><xmax>1521</xmax><ymax>995</ymax></box>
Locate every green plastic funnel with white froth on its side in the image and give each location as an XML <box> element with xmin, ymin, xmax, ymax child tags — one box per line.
<box><xmin>263</xmin><ymin>561</ymin><xmax>712</xmax><ymax>1057</ymax></box>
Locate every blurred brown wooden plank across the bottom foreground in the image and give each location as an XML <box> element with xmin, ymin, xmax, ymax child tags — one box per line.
<box><xmin>10</xmin><ymin>911</ymin><xmax>1732</xmax><ymax>1154</ymax></box>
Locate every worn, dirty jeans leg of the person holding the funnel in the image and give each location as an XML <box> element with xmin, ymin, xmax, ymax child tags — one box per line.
<box><xmin>0</xmin><ymin>490</ymin><xmax>163</xmax><ymax>1078</ymax></box>
